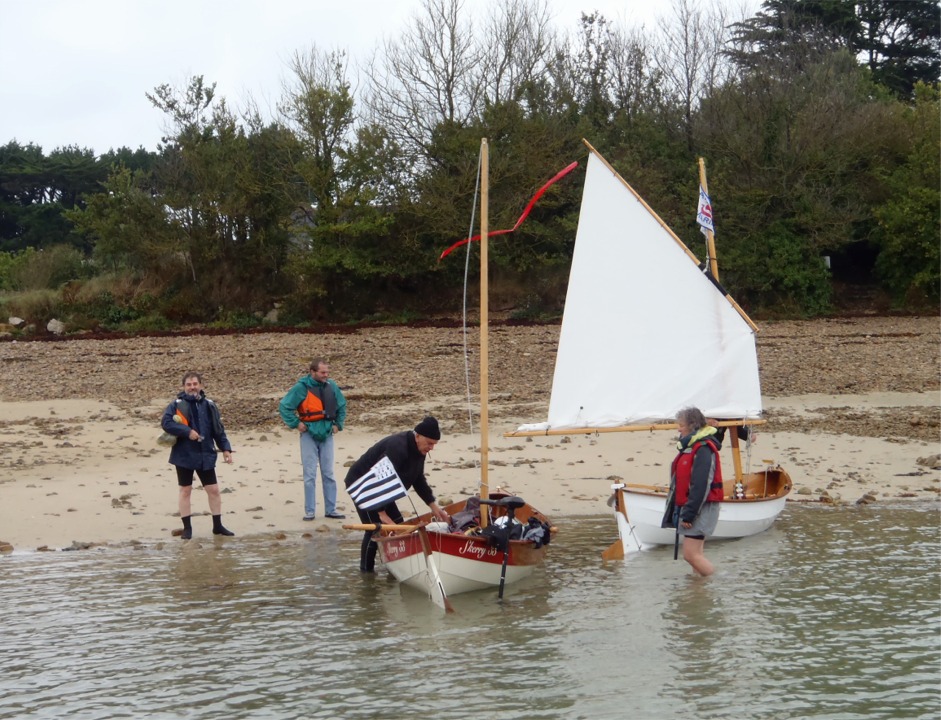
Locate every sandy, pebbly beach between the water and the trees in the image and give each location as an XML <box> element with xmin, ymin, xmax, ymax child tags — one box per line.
<box><xmin>0</xmin><ymin>317</ymin><xmax>941</xmax><ymax>552</ymax></box>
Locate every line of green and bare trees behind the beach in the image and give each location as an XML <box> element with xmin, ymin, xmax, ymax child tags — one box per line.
<box><xmin>0</xmin><ymin>0</ymin><xmax>941</xmax><ymax>330</ymax></box>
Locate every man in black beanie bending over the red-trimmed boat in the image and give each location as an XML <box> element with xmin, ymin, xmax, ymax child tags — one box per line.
<box><xmin>344</xmin><ymin>416</ymin><xmax>451</xmax><ymax>572</ymax></box>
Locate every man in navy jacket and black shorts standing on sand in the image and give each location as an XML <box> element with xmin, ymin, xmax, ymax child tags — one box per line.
<box><xmin>160</xmin><ymin>371</ymin><xmax>235</xmax><ymax>540</ymax></box>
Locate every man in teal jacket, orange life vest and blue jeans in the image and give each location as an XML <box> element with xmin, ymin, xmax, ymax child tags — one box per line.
<box><xmin>278</xmin><ymin>358</ymin><xmax>346</xmax><ymax>520</ymax></box>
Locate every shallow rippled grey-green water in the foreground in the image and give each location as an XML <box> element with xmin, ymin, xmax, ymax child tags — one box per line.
<box><xmin>0</xmin><ymin>504</ymin><xmax>941</xmax><ymax>720</ymax></box>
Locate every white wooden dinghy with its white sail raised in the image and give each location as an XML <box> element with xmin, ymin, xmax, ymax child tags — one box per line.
<box><xmin>507</xmin><ymin>142</ymin><xmax>791</xmax><ymax>558</ymax></box>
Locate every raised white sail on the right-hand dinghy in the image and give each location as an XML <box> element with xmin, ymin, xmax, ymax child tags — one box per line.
<box><xmin>520</xmin><ymin>145</ymin><xmax>761</xmax><ymax>431</ymax></box>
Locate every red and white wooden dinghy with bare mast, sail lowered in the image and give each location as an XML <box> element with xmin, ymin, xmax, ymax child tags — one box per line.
<box><xmin>344</xmin><ymin>140</ymin><xmax>551</xmax><ymax>610</ymax></box>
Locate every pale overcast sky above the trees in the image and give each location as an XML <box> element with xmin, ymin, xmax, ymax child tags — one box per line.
<box><xmin>0</xmin><ymin>0</ymin><xmax>758</xmax><ymax>154</ymax></box>
